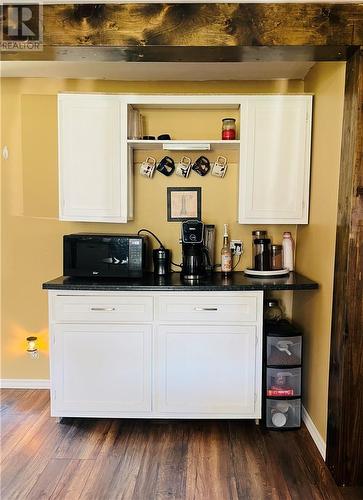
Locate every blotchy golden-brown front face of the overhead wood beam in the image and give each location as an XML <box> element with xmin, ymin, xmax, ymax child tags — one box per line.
<box><xmin>44</xmin><ymin>3</ymin><xmax>363</xmax><ymax>47</ymax></box>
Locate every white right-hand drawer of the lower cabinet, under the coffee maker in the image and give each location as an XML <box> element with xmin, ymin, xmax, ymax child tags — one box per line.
<box><xmin>156</xmin><ymin>293</ymin><xmax>257</xmax><ymax>322</ymax></box>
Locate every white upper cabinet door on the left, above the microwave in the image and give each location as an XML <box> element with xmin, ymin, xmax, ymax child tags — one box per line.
<box><xmin>58</xmin><ymin>94</ymin><xmax>128</xmax><ymax>222</ymax></box>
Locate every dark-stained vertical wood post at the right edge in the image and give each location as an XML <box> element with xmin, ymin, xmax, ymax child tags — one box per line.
<box><xmin>327</xmin><ymin>50</ymin><xmax>363</xmax><ymax>485</ymax></box>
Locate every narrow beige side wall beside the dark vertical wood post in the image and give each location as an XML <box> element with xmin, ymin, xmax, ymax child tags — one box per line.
<box><xmin>293</xmin><ymin>63</ymin><xmax>345</xmax><ymax>439</ymax></box>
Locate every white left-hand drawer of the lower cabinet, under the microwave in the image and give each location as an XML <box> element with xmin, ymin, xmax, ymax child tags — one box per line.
<box><xmin>51</xmin><ymin>295</ymin><xmax>153</xmax><ymax>323</ymax></box>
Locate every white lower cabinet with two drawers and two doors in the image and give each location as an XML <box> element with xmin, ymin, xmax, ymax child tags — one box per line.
<box><xmin>49</xmin><ymin>290</ymin><xmax>263</xmax><ymax>418</ymax></box>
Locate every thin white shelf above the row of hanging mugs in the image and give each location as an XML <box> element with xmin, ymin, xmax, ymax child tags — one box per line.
<box><xmin>127</xmin><ymin>139</ymin><xmax>240</xmax><ymax>151</ymax></box>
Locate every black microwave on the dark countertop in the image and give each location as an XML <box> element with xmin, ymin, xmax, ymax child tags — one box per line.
<box><xmin>63</xmin><ymin>233</ymin><xmax>147</xmax><ymax>278</ymax></box>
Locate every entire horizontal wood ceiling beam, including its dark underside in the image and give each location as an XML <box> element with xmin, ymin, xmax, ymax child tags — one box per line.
<box><xmin>2</xmin><ymin>3</ymin><xmax>363</xmax><ymax>62</ymax></box>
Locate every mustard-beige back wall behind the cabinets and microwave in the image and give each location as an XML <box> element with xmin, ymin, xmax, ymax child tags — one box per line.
<box><xmin>1</xmin><ymin>78</ymin><xmax>302</xmax><ymax>379</ymax></box>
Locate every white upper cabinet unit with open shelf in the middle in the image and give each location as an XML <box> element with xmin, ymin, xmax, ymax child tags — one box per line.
<box><xmin>58</xmin><ymin>94</ymin><xmax>312</xmax><ymax>224</ymax></box>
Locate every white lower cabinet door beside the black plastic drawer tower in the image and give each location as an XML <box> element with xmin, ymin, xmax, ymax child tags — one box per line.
<box><xmin>154</xmin><ymin>325</ymin><xmax>261</xmax><ymax>418</ymax></box>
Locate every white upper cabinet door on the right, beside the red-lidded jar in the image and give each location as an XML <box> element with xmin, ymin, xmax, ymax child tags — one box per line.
<box><xmin>238</xmin><ymin>96</ymin><xmax>312</xmax><ymax>224</ymax></box>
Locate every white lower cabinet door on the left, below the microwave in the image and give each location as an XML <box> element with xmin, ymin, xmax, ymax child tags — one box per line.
<box><xmin>51</xmin><ymin>324</ymin><xmax>152</xmax><ymax>416</ymax></box>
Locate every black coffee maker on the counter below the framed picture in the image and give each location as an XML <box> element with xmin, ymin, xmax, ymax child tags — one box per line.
<box><xmin>181</xmin><ymin>220</ymin><xmax>211</xmax><ymax>281</ymax></box>
